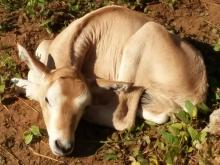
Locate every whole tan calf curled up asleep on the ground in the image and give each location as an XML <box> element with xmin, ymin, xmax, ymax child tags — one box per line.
<box><xmin>13</xmin><ymin>6</ymin><xmax>207</xmax><ymax>155</ymax></box>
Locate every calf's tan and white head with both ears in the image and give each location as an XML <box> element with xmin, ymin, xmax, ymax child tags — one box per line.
<box><xmin>13</xmin><ymin>45</ymin><xmax>91</xmax><ymax>155</ymax></box>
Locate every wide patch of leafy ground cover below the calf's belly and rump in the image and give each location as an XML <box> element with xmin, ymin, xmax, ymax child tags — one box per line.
<box><xmin>98</xmin><ymin>101</ymin><xmax>217</xmax><ymax>165</ymax></box>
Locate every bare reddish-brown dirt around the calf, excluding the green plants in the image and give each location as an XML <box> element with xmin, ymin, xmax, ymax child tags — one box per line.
<box><xmin>0</xmin><ymin>0</ymin><xmax>220</xmax><ymax>165</ymax></box>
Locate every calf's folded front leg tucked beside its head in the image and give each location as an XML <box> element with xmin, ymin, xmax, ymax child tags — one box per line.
<box><xmin>84</xmin><ymin>79</ymin><xmax>144</xmax><ymax>130</ymax></box>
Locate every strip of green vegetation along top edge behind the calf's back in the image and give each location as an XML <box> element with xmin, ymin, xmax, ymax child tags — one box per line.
<box><xmin>0</xmin><ymin>0</ymin><xmax>158</xmax><ymax>34</ymax></box>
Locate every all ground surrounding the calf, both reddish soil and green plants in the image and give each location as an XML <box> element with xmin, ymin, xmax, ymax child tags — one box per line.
<box><xmin>0</xmin><ymin>0</ymin><xmax>220</xmax><ymax>165</ymax></box>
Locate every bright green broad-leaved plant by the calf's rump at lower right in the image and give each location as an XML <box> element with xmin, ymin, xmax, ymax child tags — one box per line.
<box><xmin>160</xmin><ymin>101</ymin><xmax>207</xmax><ymax>165</ymax></box>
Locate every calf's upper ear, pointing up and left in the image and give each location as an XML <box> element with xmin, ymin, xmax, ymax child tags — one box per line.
<box><xmin>17</xmin><ymin>44</ymin><xmax>49</xmax><ymax>75</ymax></box>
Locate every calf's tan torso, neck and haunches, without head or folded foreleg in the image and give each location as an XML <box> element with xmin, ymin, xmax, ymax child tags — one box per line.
<box><xmin>42</xmin><ymin>6</ymin><xmax>207</xmax><ymax>129</ymax></box>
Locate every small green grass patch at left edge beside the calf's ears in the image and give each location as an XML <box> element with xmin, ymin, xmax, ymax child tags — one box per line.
<box><xmin>0</xmin><ymin>53</ymin><xmax>21</xmax><ymax>102</ymax></box>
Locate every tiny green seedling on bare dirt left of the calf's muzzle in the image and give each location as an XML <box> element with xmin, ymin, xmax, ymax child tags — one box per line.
<box><xmin>23</xmin><ymin>125</ymin><xmax>42</xmax><ymax>144</ymax></box>
